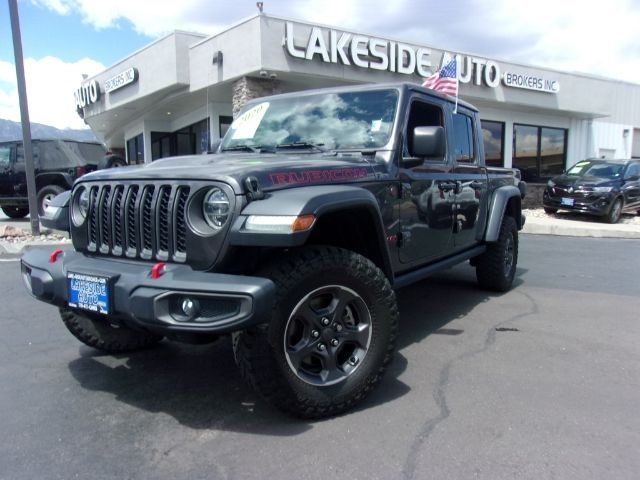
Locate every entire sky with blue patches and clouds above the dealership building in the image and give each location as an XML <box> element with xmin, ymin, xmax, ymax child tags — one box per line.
<box><xmin>0</xmin><ymin>0</ymin><xmax>640</xmax><ymax>128</ymax></box>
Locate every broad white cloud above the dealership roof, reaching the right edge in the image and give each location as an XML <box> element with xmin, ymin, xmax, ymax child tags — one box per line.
<box><xmin>31</xmin><ymin>0</ymin><xmax>640</xmax><ymax>83</ymax></box>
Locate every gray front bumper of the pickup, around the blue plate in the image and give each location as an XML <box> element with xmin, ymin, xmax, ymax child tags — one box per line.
<box><xmin>21</xmin><ymin>250</ymin><xmax>275</xmax><ymax>334</ymax></box>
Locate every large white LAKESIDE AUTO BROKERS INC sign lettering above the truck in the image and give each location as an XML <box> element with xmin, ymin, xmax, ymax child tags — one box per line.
<box><xmin>283</xmin><ymin>22</ymin><xmax>560</xmax><ymax>93</ymax></box>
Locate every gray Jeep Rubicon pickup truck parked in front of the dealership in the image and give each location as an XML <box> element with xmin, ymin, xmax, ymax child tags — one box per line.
<box><xmin>22</xmin><ymin>84</ymin><xmax>524</xmax><ymax>418</ymax></box>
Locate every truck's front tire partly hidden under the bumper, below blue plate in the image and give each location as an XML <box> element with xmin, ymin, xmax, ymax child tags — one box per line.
<box><xmin>60</xmin><ymin>308</ymin><xmax>162</xmax><ymax>353</ymax></box>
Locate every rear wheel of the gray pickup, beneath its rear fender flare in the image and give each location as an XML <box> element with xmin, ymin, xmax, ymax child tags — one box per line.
<box><xmin>476</xmin><ymin>215</ymin><xmax>518</xmax><ymax>292</ymax></box>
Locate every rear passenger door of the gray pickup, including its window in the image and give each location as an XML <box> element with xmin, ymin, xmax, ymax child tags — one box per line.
<box><xmin>449</xmin><ymin>107</ymin><xmax>487</xmax><ymax>249</ymax></box>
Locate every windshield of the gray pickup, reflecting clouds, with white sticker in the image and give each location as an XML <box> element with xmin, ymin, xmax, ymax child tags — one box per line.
<box><xmin>221</xmin><ymin>90</ymin><xmax>398</xmax><ymax>151</ymax></box>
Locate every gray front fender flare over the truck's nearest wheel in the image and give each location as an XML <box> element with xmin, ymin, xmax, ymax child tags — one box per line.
<box><xmin>229</xmin><ymin>185</ymin><xmax>393</xmax><ymax>278</ymax></box>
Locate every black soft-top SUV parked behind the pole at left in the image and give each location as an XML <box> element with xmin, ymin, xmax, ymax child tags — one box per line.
<box><xmin>0</xmin><ymin>140</ymin><xmax>105</xmax><ymax>218</ymax></box>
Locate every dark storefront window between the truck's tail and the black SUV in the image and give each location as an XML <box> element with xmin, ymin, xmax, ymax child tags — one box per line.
<box><xmin>513</xmin><ymin>124</ymin><xmax>567</xmax><ymax>182</ymax></box>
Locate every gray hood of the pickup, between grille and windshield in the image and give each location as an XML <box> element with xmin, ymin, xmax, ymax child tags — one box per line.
<box><xmin>79</xmin><ymin>152</ymin><xmax>387</xmax><ymax>194</ymax></box>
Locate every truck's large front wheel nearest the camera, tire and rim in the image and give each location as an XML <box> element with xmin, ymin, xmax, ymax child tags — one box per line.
<box><xmin>233</xmin><ymin>247</ymin><xmax>398</xmax><ymax>418</ymax></box>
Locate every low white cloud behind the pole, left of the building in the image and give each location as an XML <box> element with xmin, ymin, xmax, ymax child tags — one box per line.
<box><xmin>0</xmin><ymin>57</ymin><xmax>105</xmax><ymax>128</ymax></box>
